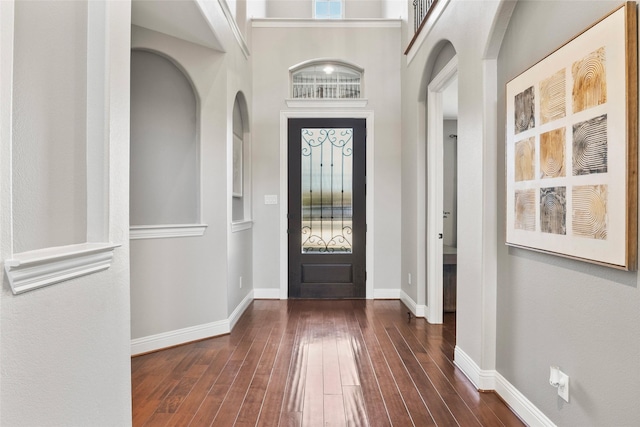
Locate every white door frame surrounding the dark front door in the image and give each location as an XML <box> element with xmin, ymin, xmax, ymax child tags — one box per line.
<box><xmin>279</xmin><ymin>110</ymin><xmax>375</xmax><ymax>299</ymax></box>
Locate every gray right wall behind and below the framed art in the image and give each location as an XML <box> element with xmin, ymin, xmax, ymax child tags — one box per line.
<box><xmin>497</xmin><ymin>1</ymin><xmax>640</xmax><ymax>426</ymax></box>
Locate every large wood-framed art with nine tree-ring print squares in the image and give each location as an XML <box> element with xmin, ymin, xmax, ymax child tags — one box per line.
<box><xmin>506</xmin><ymin>2</ymin><xmax>638</xmax><ymax>270</ymax></box>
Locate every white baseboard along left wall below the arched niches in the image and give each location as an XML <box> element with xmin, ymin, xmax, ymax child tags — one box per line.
<box><xmin>131</xmin><ymin>291</ymin><xmax>253</xmax><ymax>356</ymax></box>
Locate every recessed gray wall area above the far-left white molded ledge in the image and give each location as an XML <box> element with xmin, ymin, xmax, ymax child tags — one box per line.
<box><xmin>13</xmin><ymin>1</ymin><xmax>87</xmax><ymax>252</ymax></box>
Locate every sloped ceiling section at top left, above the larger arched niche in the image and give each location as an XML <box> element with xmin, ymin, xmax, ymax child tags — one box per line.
<box><xmin>131</xmin><ymin>0</ymin><xmax>224</xmax><ymax>52</ymax></box>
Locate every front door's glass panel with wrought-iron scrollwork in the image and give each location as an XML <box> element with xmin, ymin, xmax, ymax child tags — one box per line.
<box><xmin>300</xmin><ymin>128</ymin><xmax>353</xmax><ymax>254</ymax></box>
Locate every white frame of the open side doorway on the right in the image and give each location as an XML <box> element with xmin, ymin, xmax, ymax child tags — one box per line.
<box><xmin>418</xmin><ymin>56</ymin><xmax>458</xmax><ymax>324</ymax></box>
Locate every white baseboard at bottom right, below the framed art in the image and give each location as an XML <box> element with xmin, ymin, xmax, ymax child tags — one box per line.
<box><xmin>454</xmin><ymin>346</ymin><xmax>555</xmax><ymax>427</ymax></box>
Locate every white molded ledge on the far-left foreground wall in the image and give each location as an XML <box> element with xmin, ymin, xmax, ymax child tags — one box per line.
<box><xmin>4</xmin><ymin>243</ymin><xmax>120</xmax><ymax>295</ymax></box>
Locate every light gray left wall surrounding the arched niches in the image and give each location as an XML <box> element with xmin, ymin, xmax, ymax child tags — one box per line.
<box><xmin>131</xmin><ymin>21</ymin><xmax>253</xmax><ymax>341</ymax></box>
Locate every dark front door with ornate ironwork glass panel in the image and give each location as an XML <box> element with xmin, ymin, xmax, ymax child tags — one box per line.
<box><xmin>288</xmin><ymin>118</ymin><xmax>367</xmax><ymax>298</ymax></box>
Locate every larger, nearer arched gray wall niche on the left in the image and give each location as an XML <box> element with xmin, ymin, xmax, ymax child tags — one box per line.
<box><xmin>130</xmin><ymin>49</ymin><xmax>201</xmax><ymax>227</ymax></box>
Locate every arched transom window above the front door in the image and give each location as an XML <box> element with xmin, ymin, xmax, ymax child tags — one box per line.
<box><xmin>289</xmin><ymin>60</ymin><xmax>364</xmax><ymax>99</ymax></box>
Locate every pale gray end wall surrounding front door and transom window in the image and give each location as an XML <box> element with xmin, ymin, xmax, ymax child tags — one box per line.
<box><xmin>252</xmin><ymin>21</ymin><xmax>401</xmax><ymax>295</ymax></box>
